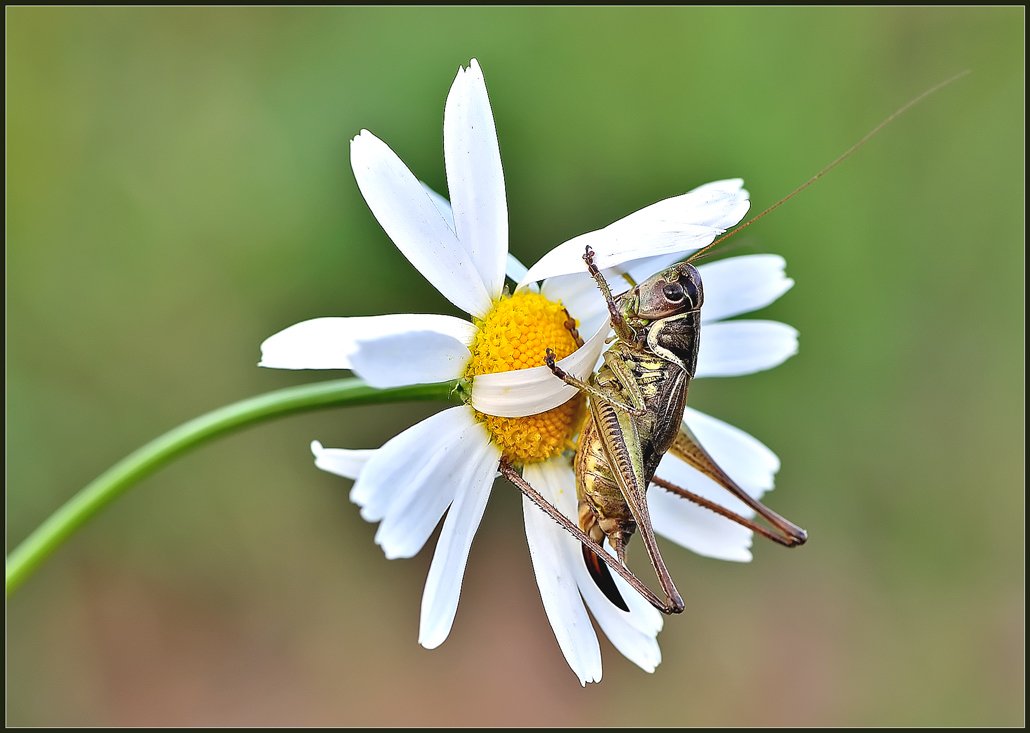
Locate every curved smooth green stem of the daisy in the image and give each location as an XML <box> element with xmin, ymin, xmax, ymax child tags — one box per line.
<box><xmin>7</xmin><ymin>378</ymin><xmax>460</xmax><ymax>596</ymax></box>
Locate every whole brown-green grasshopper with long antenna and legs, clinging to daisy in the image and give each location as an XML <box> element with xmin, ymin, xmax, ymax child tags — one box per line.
<box><xmin>500</xmin><ymin>71</ymin><xmax>968</xmax><ymax>614</ymax></box>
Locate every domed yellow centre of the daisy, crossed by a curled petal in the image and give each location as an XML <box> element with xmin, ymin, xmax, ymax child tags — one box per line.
<box><xmin>466</xmin><ymin>290</ymin><xmax>585</xmax><ymax>464</ymax></box>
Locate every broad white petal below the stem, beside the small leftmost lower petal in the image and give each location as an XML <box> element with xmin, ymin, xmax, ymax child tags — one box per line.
<box><xmin>350</xmin><ymin>405</ymin><xmax>475</xmax><ymax>522</ymax></box>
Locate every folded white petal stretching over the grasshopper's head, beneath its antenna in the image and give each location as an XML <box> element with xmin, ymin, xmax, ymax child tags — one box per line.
<box><xmin>520</xmin><ymin>178</ymin><xmax>750</xmax><ymax>284</ymax></box>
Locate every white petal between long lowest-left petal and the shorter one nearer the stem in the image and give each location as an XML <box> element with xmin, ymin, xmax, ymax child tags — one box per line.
<box><xmin>376</xmin><ymin>422</ymin><xmax>500</xmax><ymax>560</ymax></box>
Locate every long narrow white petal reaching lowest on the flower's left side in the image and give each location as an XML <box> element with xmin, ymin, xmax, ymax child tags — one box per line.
<box><xmin>418</xmin><ymin>443</ymin><xmax>501</xmax><ymax>649</ymax></box>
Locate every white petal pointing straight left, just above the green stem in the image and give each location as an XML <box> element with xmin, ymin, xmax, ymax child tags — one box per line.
<box><xmin>259</xmin><ymin>313</ymin><xmax>476</xmax><ymax>387</ymax></box>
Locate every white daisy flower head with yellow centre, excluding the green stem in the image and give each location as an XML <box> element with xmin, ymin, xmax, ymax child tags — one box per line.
<box><xmin>261</xmin><ymin>60</ymin><xmax>796</xmax><ymax>684</ymax></box>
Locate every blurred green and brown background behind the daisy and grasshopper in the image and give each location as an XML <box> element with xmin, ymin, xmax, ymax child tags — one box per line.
<box><xmin>5</xmin><ymin>7</ymin><xmax>1025</xmax><ymax>727</ymax></box>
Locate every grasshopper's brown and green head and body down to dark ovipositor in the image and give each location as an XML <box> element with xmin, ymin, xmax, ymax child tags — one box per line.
<box><xmin>575</xmin><ymin>260</ymin><xmax>703</xmax><ymax>610</ymax></box>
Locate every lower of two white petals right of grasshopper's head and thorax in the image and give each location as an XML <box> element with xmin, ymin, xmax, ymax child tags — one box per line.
<box><xmin>694</xmin><ymin>320</ymin><xmax>797</xmax><ymax>377</ymax></box>
